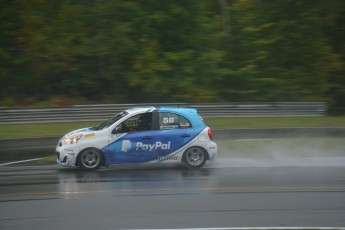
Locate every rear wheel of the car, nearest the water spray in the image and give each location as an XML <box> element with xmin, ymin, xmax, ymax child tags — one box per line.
<box><xmin>182</xmin><ymin>146</ymin><xmax>207</xmax><ymax>169</ymax></box>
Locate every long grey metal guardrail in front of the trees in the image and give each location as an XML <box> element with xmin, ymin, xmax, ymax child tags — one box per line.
<box><xmin>0</xmin><ymin>102</ymin><xmax>326</xmax><ymax>124</ymax></box>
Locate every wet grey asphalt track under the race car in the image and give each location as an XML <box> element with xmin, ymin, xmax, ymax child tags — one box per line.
<box><xmin>0</xmin><ymin>158</ymin><xmax>345</xmax><ymax>230</ymax></box>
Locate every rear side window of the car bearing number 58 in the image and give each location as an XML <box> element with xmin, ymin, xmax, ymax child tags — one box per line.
<box><xmin>159</xmin><ymin>113</ymin><xmax>192</xmax><ymax>130</ymax></box>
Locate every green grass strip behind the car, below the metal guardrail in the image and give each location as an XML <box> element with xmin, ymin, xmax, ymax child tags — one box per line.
<box><xmin>0</xmin><ymin>116</ymin><xmax>345</xmax><ymax>139</ymax></box>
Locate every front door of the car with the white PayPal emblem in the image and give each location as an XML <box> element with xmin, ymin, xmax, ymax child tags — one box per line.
<box><xmin>102</xmin><ymin>113</ymin><xmax>155</xmax><ymax>164</ymax></box>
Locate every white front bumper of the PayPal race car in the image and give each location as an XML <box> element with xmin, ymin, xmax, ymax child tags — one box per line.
<box><xmin>56</xmin><ymin>142</ymin><xmax>79</xmax><ymax>167</ymax></box>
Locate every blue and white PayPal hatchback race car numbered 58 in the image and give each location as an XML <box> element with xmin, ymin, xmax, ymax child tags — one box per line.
<box><xmin>56</xmin><ymin>107</ymin><xmax>217</xmax><ymax>170</ymax></box>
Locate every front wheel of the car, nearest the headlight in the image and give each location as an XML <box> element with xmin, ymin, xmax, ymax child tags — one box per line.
<box><xmin>78</xmin><ymin>148</ymin><xmax>104</xmax><ymax>171</ymax></box>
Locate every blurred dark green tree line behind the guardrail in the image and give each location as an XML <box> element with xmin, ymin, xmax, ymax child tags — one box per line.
<box><xmin>0</xmin><ymin>0</ymin><xmax>345</xmax><ymax>113</ymax></box>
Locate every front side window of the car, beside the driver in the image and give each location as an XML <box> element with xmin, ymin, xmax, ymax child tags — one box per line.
<box><xmin>112</xmin><ymin>113</ymin><xmax>152</xmax><ymax>133</ymax></box>
